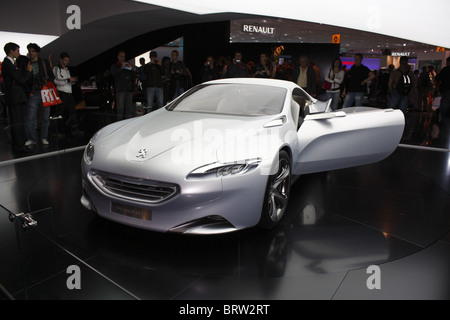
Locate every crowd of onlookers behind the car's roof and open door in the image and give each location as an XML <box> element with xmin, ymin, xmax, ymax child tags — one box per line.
<box><xmin>193</xmin><ymin>52</ymin><xmax>450</xmax><ymax>121</ymax></box>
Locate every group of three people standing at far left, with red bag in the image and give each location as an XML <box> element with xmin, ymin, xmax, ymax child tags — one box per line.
<box><xmin>1</xmin><ymin>42</ymin><xmax>83</xmax><ymax>152</ymax></box>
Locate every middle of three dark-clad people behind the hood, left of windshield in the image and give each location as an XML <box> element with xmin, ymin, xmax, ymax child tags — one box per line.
<box><xmin>144</xmin><ymin>51</ymin><xmax>164</xmax><ymax>113</ymax></box>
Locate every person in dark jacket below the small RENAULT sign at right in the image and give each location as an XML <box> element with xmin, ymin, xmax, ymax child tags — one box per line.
<box><xmin>388</xmin><ymin>57</ymin><xmax>414</xmax><ymax>113</ymax></box>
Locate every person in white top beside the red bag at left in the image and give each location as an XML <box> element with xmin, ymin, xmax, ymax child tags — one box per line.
<box><xmin>53</xmin><ymin>52</ymin><xmax>83</xmax><ymax>136</ymax></box>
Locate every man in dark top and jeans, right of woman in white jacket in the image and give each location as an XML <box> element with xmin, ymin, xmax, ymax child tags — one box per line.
<box><xmin>342</xmin><ymin>53</ymin><xmax>375</xmax><ymax>108</ymax></box>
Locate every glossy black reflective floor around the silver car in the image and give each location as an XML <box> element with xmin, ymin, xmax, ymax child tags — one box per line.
<box><xmin>0</xmin><ymin>142</ymin><xmax>450</xmax><ymax>300</ymax></box>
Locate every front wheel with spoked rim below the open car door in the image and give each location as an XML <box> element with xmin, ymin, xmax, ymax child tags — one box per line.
<box><xmin>259</xmin><ymin>150</ymin><xmax>291</xmax><ymax>230</ymax></box>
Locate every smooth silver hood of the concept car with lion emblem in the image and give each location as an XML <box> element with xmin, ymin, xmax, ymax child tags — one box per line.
<box><xmin>95</xmin><ymin>109</ymin><xmax>271</xmax><ymax>165</ymax></box>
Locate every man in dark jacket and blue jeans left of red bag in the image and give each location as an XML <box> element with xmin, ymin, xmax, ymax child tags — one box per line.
<box><xmin>25</xmin><ymin>43</ymin><xmax>55</xmax><ymax>147</ymax></box>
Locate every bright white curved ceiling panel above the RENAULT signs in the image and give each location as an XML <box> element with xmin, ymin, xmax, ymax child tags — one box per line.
<box><xmin>135</xmin><ymin>0</ymin><xmax>450</xmax><ymax>48</ymax></box>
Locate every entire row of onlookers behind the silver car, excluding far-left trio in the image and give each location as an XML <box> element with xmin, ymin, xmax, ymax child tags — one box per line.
<box><xmin>103</xmin><ymin>50</ymin><xmax>450</xmax><ymax>146</ymax></box>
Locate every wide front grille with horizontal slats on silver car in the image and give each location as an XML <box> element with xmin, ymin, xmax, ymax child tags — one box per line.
<box><xmin>88</xmin><ymin>170</ymin><xmax>179</xmax><ymax>204</ymax></box>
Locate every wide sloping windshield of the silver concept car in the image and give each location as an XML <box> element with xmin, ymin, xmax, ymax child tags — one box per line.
<box><xmin>167</xmin><ymin>83</ymin><xmax>287</xmax><ymax>116</ymax></box>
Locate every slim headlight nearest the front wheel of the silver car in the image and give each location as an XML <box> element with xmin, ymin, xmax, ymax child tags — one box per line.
<box><xmin>186</xmin><ymin>158</ymin><xmax>262</xmax><ymax>179</ymax></box>
